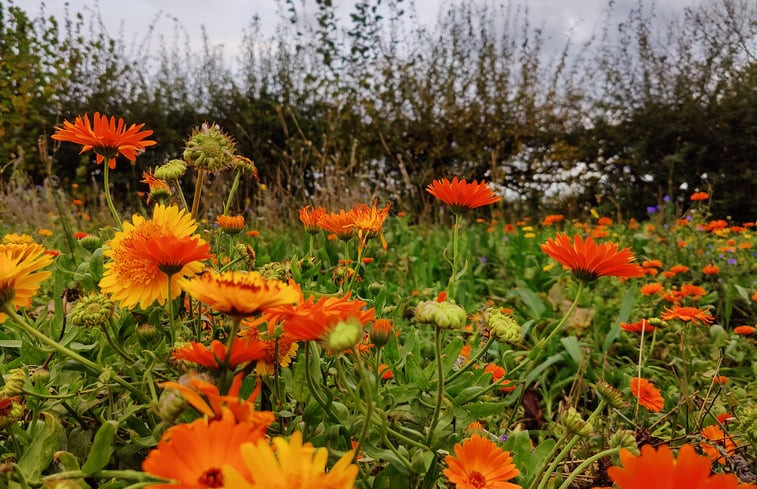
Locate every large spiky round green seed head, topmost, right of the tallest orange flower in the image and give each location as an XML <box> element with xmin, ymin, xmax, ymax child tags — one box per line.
<box><xmin>184</xmin><ymin>123</ymin><xmax>236</xmax><ymax>172</ymax></box>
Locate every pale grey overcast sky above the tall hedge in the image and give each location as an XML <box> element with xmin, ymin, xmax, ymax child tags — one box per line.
<box><xmin>16</xmin><ymin>0</ymin><xmax>700</xmax><ymax>62</ymax></box>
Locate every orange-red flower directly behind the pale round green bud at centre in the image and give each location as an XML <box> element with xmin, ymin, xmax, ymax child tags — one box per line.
<box><xmin>265</xmin><ymin>294</ymin><xmax>373</xmax><ymax>341</ymax></box>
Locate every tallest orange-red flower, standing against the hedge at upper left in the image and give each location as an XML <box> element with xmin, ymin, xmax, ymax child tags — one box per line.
<box><xmin>52</xmin><ymin>112</ymin><xmax>155</xmax><ymax>170</ymax></box>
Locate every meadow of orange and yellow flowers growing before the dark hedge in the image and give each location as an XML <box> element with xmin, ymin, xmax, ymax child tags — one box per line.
<box><xmin>0</xmin><ymin>114</ymin><xmax>757</xmax><ymax>489</ymax></box>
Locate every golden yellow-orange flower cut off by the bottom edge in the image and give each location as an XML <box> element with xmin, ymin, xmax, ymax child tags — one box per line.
<box><xmin>223</xmin><ymin>431</ymin><xmax>358</xmax><ymax>489</ymax></box>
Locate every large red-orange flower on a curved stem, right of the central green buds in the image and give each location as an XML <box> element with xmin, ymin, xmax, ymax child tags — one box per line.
<box><xmin>541</xmin><ymin>233</ymin><xmax>644</xmax><ymax>282</ymax></box>
